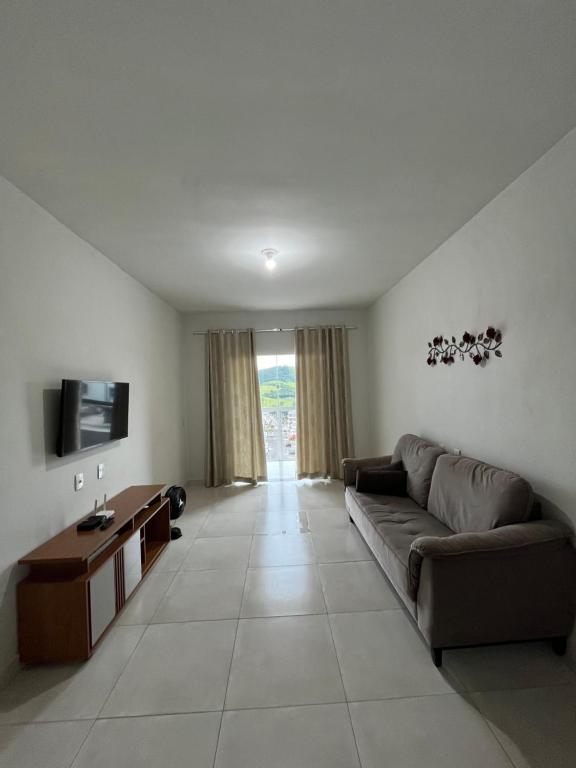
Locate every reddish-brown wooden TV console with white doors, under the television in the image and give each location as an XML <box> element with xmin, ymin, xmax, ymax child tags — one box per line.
<box><xmin>18</xmin><ymin>485</ymin><xmax>170</xmax><ymax>663</ymax></box>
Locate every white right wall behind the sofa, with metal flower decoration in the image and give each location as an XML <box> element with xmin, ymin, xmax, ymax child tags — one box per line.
<box><xmin>371</xmin><ymin>130</ymin><xmax>576</xmax><ymax>660</ymax></box>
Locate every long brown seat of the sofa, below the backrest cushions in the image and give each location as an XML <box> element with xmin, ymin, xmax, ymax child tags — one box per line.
<box><xmin>346</xmin><ymin>488</ymin><xmax>453</xmax><ymax>601</ymax></box>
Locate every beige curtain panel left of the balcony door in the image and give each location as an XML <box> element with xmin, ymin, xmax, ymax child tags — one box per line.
<box><xmin>206</xmin><ymin>330</ymin><xmax>266</xmax><ymax>486</ymax></box>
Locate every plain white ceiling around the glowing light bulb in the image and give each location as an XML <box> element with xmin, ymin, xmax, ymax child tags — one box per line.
<box><xmin>0</xmin><ymin>0</ymin><xmax>576</xmax><ymax>310</ymax></box>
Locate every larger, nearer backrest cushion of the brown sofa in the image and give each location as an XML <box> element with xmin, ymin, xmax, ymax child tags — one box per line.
<box><xmin>428</xmin><ymin>454</ymin><xmax>534</xmax><ymax>533</ymax></box>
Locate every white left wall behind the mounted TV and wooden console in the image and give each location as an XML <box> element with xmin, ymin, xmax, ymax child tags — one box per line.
<box><xmin>0</xmin><ymin>177</ymin><xmax>184</xmax><ymax>678</ymax></box>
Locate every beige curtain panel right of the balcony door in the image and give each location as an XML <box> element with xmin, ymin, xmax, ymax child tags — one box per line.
<box><xmin>296</xmin><ymin>328</ymin><xmax>353</xmax><ymax>478</ymax></box>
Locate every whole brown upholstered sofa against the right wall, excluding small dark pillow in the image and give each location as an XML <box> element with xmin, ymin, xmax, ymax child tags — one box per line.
<box><xmin>343</xmin><ymin>435</ymin><xmax>576</xmax><ymax>666</ymax></box>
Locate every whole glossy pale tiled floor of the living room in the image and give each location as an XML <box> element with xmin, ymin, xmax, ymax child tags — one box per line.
<box><xmin>0</xmin><ymin>481</ymin><xmax>576</xmax><ymax>768</ymax></box>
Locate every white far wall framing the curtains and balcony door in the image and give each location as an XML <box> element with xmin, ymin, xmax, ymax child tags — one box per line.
<box><xmin>184</xmin><ymin>306</ymin><xmax>371</xmax><ymax>483</ymax></box>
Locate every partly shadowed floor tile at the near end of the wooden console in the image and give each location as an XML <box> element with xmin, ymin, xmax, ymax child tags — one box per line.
<box><xmin>0</xmin><ymin>626</ymin><xmax>144</xmax><ymax>723</ymax></box>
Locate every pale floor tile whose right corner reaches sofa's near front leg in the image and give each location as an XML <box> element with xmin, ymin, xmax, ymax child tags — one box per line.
<box><xmin>330</xmin><ymin>611</ymin><xmax>454</xmax><ymax>701</ymax></box>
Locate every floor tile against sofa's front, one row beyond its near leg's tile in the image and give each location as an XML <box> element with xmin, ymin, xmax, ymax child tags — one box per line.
<box><xmin>318</xmin><ymin>561</ymin><xmax>400</xmax><ymax>613</ymax></box>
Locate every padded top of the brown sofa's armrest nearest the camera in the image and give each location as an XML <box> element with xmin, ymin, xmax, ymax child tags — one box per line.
<box><xmin>408</xmin><ymin>520</ymin><xmax>572</xmax><ymax>600</ymax></box>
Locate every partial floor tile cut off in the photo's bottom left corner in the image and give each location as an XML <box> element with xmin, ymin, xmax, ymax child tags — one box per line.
<box><xmin>0</xmin><ymin>720</ymin><xmax>92</xmax><ymax>768</ymax></box>
